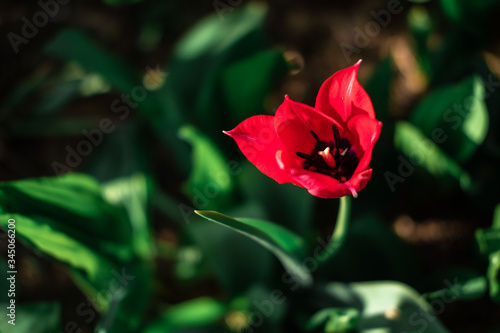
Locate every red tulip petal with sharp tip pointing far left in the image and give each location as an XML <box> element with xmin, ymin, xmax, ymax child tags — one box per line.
<box><xmin>224</xmin><ymin>115</ymin><xmax>296</xmax><ymax>184</ymax></box>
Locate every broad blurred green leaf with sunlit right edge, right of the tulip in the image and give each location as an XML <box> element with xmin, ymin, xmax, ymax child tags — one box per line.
<box><xmin>411</xmin><ymin>76</ymin><xmax>489</xmax><ymax>163</ymax></box>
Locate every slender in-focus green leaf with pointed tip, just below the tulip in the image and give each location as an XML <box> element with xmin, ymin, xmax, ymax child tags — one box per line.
<box><xmin>196</xmin><ymin>211</ymin><xmax>312</xmax><ymax>285</ymax></box>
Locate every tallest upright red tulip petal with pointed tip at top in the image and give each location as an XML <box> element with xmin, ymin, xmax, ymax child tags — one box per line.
<box><xmin>315</xmin><ymin>60</ymin><xmax>375</xmax><ymax>124</ymax></box>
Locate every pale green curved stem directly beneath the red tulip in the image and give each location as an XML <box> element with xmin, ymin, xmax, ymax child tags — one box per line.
<box><xmin>320</xmin><ymin>196</ymin><xmax>351</xmax><ymax>262</ymax></box>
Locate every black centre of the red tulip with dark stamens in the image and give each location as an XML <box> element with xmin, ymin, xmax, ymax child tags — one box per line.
<box><xmin>296</xmin><ymin>124</ymin><xmax>359</xmax><ymax>182</ymax></box>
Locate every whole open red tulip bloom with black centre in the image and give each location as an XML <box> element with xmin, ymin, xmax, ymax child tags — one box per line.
<box><xmin>224</xmin><ymin>60</ymin><xmax>382</xmax><ymax>198</ymax></box>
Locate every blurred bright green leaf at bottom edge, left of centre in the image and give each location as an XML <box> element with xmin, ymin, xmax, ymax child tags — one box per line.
<box><xmin>142</xmin><ymin>297</ymin><xmax>226</xmax><ymax>333</ymax></box>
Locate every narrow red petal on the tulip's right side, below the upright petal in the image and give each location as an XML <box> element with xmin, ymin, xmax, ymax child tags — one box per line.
<box><xmin>347</xmin><ymin>116</ymin><xmax>382</xmax><ymax>173</ymax></box>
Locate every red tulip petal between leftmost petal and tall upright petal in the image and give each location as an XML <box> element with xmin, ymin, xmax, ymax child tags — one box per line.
<box><xmin>274</xmin><ymin>96</ymin><xmax>350</xmax><ymax>164</ymax></box>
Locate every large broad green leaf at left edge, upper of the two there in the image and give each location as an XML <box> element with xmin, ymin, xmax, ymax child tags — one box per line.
<box><xmin>0</xmin><ymin>173</ymin><xmax>133</xmax><ymax>261</ymax></box>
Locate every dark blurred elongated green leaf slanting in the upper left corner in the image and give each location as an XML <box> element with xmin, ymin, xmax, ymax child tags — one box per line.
<box><xmin>44</xmin><ymin>28</ymin><xmax>140</xmax><ymax>92</ymax></box>
